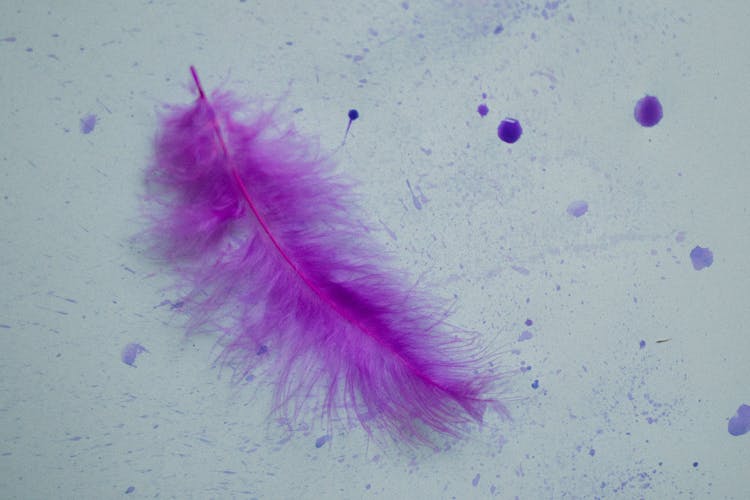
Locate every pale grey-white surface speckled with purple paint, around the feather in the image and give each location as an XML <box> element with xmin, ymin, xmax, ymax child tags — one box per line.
<box><xmin>0</xmin><ymin>0</ymin><xmax>750</xmax><ymax>498</ymax></box>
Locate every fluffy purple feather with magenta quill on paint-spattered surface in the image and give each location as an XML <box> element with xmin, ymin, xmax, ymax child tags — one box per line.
<box><xmin>146</xmin><ymin>67</ymin><xmax>505</xmax><ymax>443</ymax></box>
